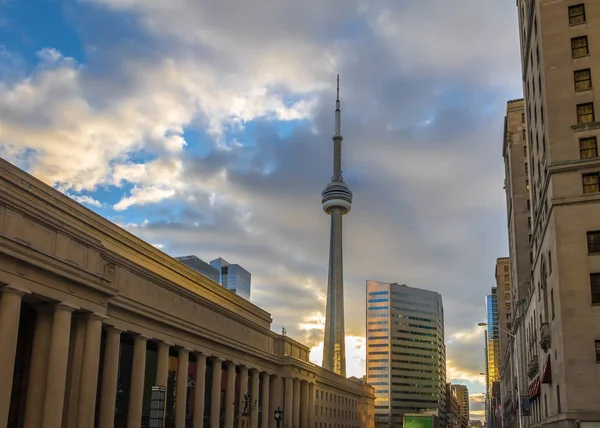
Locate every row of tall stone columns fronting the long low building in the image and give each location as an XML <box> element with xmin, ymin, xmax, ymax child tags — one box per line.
<box><xmin>0</xmin><ymin>285</ymin><xmax>315</xmax><ymax>428</ymax></box>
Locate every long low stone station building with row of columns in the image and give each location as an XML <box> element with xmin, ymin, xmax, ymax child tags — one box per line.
<box><xmin>0</xmin><ymin>159</ymin><xmax>374</xmax><ymax>428</ymax></box>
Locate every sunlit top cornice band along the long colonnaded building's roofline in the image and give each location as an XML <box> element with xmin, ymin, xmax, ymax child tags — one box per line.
<box><xmin>0</xmin><ymin>158</ymin><xmax>272</xmax><ymax>324</ymax></box>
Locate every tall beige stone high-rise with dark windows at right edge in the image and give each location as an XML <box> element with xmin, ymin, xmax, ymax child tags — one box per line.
<box><xmin>502</xmin><ymin>0</ymin><xmax>600</xmax><ymax>428</ymax></box>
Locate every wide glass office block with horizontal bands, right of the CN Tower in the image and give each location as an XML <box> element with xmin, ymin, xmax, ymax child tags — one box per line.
<box><xmin>366</xmin><ymin>280</ymin><xmax>446</xmax><ymax>427</ymax></box>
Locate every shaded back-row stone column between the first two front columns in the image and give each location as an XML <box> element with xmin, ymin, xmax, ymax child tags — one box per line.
<box><xmin>23</xmin><ymin>305</ymin><xmax>52</xmax><ymax>428</ymax></box>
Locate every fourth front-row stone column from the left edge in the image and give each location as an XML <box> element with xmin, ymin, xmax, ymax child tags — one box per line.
<box><xmin>98</xmin><ymin>327</ymin><xmax>121</xmax><ymax>428</ymax></box>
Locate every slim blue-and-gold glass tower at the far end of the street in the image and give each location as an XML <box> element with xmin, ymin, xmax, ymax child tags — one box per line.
<box><xmin>485</xmin><ymin>287</ymin><xmax>500</xmax><ymax>428</ymax></box>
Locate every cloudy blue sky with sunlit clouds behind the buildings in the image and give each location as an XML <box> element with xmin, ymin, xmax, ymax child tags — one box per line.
<box><xmin>0</xmin><ymin>0</ymin><xmax>522</xmax><ymax>418</ymax></box>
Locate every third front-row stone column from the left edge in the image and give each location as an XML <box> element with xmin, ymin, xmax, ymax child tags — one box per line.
<box><xmin>77</xmin><ymin>314</ymin><xmax>102</xmax><ymax>427</ymax></box>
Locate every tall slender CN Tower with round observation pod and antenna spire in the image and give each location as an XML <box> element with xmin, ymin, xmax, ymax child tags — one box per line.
<box><xmin>321</xmin><ymin>75</ymin><xmax>352</xmax><ymax>377</ymax></box>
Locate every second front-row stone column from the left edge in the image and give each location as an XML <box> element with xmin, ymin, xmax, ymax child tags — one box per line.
<box><xmin>42</xmin><ymin>304</ymin><xmax>76</xmax><ymax>428</ymax></box>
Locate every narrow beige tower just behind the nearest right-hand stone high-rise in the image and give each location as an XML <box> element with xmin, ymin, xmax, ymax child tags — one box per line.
<box><xmin>500</xmin><ymin>99</ymin><xmax>533</xmax><ymax>428</ymax></box>
